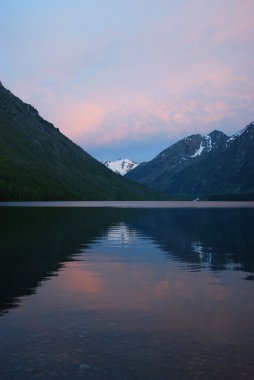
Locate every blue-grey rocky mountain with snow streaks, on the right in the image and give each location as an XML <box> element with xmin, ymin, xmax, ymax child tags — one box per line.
<box><xmin>127</xmin><ymin>122</ymin><xmax>254</xmax><ymax>199</ymax></box>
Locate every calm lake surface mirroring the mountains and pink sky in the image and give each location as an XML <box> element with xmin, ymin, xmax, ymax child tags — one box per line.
<box><xmin>0</xmin><ymin>208</ymin><xmax>254</xmax><ymax>380</ymax></box>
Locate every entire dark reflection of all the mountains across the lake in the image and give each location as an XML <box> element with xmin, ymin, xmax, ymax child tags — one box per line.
<box><xmin>0</xmin><ymin>208</ymin><xmax>254</xmax><ymax>312</ymax></box>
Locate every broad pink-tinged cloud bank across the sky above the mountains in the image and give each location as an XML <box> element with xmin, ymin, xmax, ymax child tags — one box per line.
<box><xmin>6</xmin><ymin>0</ymin><xmax>254</xmax><ymax>157</ymax></box>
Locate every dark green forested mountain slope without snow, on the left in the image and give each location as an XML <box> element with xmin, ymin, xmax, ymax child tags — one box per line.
<box><xmin>0</xmin><ymin>83</ymin><xmax>163</xmax><ymax>201</ymax></box>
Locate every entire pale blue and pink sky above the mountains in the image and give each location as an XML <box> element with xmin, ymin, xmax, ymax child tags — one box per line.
<box><xmin>0</xmin><ymin>0</ymin><xmax>254</xmax><ymax>162</ymax></box>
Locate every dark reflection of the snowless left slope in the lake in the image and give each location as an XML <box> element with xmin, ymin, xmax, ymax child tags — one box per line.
<box><xmin>0</xmin><ymin>208</ymin><xmax>119</xmax><ymax>313</ymax></box>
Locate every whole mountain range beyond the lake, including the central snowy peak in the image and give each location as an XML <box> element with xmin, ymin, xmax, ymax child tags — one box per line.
<box><xmin>0</xmin><ymin>82</ymin><xmax>254</xmax><ymax>201</ymax></box>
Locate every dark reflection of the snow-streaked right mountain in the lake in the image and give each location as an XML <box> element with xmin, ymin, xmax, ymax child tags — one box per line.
<box><xmin>130</xmin><ymin>209</ymin><xmax>254</xmax><ymax>272</ymax></box>
